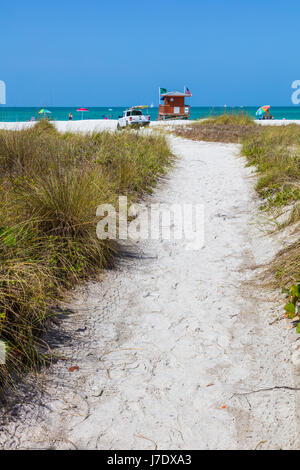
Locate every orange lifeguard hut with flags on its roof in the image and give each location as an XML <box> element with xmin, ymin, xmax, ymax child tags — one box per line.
<box><xmin>157</xmin><ymin>87</ymin><xmax>192</xmax><ymax>120</ymax></box>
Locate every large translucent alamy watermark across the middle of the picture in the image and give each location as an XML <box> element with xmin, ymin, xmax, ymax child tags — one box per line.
<box><xmin>96</xmin><ymin>196</ymin><xmax>204</xmax><ymax>250</ymax></box>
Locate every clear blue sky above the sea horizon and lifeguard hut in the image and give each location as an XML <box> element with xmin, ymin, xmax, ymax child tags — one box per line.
<box><xmin>0</xmin><ymin>0</ymin><xmax>300</xmax><ymax>106</ymax></box>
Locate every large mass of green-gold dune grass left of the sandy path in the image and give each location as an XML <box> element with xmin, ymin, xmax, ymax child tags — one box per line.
<box><xmin>0</xmin><ymin>121</ymin><xmax>172</xmax><ymax>383</ymax></box>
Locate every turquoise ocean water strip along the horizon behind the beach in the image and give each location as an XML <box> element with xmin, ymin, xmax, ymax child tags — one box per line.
<box><xmin>0</xmin><ymin>106</ymin><xmax>300</xmax><ymax>122</ymax></box>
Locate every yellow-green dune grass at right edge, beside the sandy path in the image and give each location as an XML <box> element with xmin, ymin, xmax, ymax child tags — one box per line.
<box><xmin>242</xmin><ymin>124</ymin><xmax>300</xmax><ymax>287</ymax></box>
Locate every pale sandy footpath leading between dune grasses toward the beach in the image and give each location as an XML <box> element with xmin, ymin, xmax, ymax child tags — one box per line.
<box><xmin>0</xmin><ymin>137</ymin><xmax>299</xmax><ymax>449</ymax></box>
